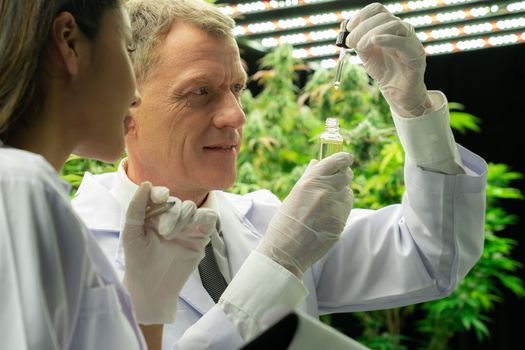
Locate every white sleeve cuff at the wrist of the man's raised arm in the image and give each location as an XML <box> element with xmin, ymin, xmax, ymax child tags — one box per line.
<box><xmin>393</xmin><ymin>91</ymin><xmax>465</xmax><ymax>175</ymax></box>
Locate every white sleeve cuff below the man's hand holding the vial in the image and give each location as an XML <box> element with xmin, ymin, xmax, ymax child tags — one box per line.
<box><xmin>219</xmin><ymin>251</ymin><xmax>308</xmax><ymax>340</ymax></box>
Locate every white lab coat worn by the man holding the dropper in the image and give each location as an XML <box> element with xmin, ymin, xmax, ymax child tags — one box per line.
<box><xmin>73</xmin><ymin>146</ymin><xmax>487</xmax><ymax>349</ymax></box>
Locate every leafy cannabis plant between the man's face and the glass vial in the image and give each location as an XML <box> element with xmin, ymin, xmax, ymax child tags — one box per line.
<box><xmin>234</xmin><ymin>46</ymin><xmax>316</xmax><ymax>197</ymax></box>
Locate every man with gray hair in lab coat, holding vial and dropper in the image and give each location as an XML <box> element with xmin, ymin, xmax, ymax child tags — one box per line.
<box><xmin>73</xmin><ymin>0</ymin><xmax>487</xmax><ymax>349</ymax></box>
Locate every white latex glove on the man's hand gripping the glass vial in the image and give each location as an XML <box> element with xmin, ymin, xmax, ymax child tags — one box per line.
<box><xmin>256</xmin><ymin>152</ymin><xmax>354</xmax><ymax>278</ymax></box>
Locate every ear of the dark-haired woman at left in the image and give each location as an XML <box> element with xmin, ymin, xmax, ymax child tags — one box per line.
<box><xmin>52</xmin><ymin>12</ymin><xmax>86</xmax><ymax>76</ymax></box>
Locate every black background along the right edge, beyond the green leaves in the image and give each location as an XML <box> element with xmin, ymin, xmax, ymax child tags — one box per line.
<box><xmin>425</xmin><ymin>44</ymin><xmax>525</xmax><ymax>349</ymax></box>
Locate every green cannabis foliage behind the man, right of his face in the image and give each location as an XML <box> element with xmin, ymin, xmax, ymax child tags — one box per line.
<box><xmin>232</xmin><ymin>46</ymin><xmax>525</xmax><ymax>350</ymax></box>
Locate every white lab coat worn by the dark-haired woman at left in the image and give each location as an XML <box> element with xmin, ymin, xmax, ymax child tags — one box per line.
<box><xmin>0</xmin><ymin>144</ymin><xmax>145</xmax><ymax>350</ymax></box>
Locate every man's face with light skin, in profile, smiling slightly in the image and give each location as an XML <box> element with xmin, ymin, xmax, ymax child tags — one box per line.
<box><xmin>126</xmin><ymin>22</ymin><xmax>246</xmax><ymax>199</ymax></box>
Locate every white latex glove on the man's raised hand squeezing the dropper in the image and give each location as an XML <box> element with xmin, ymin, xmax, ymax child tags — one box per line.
<box><xmin>346</xmin><ymin>3</ymin><xmax>432</xmax><ymax>117</ymax></box>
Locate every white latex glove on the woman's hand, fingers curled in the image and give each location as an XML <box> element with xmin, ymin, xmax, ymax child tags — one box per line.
<box><xmin>121</xmin><ymin>182</ymin><xmax>218</xmax><ymax>324</ymax></box>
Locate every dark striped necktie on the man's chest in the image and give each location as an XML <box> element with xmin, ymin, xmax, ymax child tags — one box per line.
<box><xmin>199</xmin><ymin>231</ymin><xmax>228</xmax><ymax>303</ymax></box>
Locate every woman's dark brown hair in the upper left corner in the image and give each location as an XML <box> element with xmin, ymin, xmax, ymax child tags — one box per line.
<box><xmin>0</xmin><ymin>0</ymin><xmax>121</xmax><ymax>139</ymax></box>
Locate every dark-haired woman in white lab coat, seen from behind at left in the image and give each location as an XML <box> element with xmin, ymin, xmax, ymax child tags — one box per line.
<box><xmin>0</xmin><ymin>0</ymin><xmax>217</xmax><ymax>349</ymax></box>
